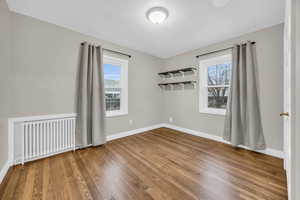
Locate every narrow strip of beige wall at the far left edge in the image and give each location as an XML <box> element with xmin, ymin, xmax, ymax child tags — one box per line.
<box><xmin>0</xmin><ymin>0</ymin><xmax>11</xmax><ymax>170</ymax></box>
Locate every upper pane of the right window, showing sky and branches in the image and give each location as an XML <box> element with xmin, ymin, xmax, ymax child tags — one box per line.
<box><xmin>207</xmin><ymin>63</ymin><xmax>231</xmax><ymax>85</ymax></box>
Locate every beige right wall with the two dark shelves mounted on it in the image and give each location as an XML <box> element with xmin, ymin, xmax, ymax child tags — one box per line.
<box><xmin>163</xmin><ymin>24</ymin><xmax>283</xmax><ymax>150</ymax></box>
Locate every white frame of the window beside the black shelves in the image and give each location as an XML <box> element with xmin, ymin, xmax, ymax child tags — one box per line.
<box><xmin>199</xmin><ymin>53</ymin><xmax>232</xmax><ymax>115</ymax></box>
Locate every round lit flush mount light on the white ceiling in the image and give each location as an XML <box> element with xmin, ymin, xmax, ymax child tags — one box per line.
<box><xmin>146</xmin><ymin>7</ymin><xmax>169</xmax><ymax>24</ymax></box>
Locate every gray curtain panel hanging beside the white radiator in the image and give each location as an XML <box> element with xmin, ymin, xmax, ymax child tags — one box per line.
<box><xmin>75</xmin><ymin>42</ymin><xmax>106</xmax><ymax>147</ymax></box>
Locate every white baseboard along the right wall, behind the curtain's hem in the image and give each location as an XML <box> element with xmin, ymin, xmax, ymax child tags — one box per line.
<box><xmin>162</xmin><ymin>123</ymin><xmax>284</xmax><ymax>159</ymax></box>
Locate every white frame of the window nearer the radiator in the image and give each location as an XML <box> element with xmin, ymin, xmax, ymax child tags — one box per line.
<box><xmin>103</xmin><ymin>55</ymin><xmax>129</xmax><ymax>117</ymax></box>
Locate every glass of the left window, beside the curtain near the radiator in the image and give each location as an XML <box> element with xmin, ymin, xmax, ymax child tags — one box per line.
<box><xmin>104</xmin><ymin>64</ymin><xmax>121</xmax><ymax>111</ymax></box>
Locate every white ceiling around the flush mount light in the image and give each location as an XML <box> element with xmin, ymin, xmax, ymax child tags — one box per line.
<box><xmin>7</xmin><ymin>0</ymin><xmax>285</xmax><ymax>58</ymax></box>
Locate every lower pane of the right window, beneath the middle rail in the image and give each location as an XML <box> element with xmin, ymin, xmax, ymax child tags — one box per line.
<box><xmin>208</xmin><ymin>87</ymin><xmax>229</xmax><ymax>109</ymax></box>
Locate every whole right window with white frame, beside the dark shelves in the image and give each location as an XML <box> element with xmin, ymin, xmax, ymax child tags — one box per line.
<box><xmin>199</xmin><ymin>54</ymin><xmax>232</xmax><ymax>115</ymax></box>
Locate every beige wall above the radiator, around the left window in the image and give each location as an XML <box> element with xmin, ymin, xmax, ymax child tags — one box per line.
<box><xmin>11</xmin><ymin>13</ymin><xmax>162</xmax><ymax>134</ymax></box>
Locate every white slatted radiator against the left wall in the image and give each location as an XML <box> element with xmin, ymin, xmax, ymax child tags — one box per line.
<box><xmin>21</xmin><ymin>117</ymin><xmax>75</xmax><ymax>164</ymax></box>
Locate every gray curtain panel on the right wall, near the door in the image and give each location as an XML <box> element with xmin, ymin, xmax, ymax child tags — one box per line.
<box><xmin>223</xmin><ymin>42</ymin><xmax>266</xmax><ymax>150</ymax></box>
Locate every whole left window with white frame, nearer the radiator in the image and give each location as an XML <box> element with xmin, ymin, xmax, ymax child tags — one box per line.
<box><xmin>103</xmin><ymin>55</ymin><xmax>128</xmax><ymax>117</ymax></box>
